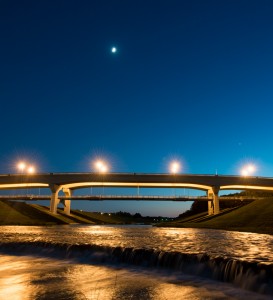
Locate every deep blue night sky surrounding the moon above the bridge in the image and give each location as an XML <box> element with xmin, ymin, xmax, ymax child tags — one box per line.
<box><xmin>0</xmin><ymin>0</ymin><xmax>273</xmax><ymax>215</ymax></box>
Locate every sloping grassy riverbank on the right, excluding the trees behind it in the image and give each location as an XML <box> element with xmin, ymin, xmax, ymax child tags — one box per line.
<box><xmin>157</xmin><ymin>198</ymin><xmax>273</xmax><ymax>235</ymax></box>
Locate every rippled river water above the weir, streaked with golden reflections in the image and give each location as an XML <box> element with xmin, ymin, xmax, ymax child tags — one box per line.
<box><xmin>0</xmin><ymin>226</ymin><xmax>273</xmax><ymax>263</ymax></box>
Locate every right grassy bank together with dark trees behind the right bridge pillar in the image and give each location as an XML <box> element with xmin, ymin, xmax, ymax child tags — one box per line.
<box><xmin>156</xmin><ymin>191</ymin><xmax>273</xmax><ymax>235</ymax></box>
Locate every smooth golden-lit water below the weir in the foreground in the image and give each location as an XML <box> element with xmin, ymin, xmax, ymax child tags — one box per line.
<box><xmin>0</xmin><ymin>256</ymin><xmax>270</xmax><ymax>300</ymax></box>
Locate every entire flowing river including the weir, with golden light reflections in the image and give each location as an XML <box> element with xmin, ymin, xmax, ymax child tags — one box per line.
<box><xmin>0</xmin><ymin>225</ymin><xmax>273</xmax><ymax>300</ymax></box>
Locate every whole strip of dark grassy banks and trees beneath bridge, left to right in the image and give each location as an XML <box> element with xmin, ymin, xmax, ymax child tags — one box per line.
<box><xmin>0</xmin><ymin>195</ymin><xmax>273</xmax><ymax>235</ymax></box>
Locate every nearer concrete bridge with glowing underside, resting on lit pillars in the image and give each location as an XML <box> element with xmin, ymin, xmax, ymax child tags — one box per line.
<box><xmin>0</xmin><ymin>173</ymin><xmax>273</xmax><ymax>215</ymax></box>
